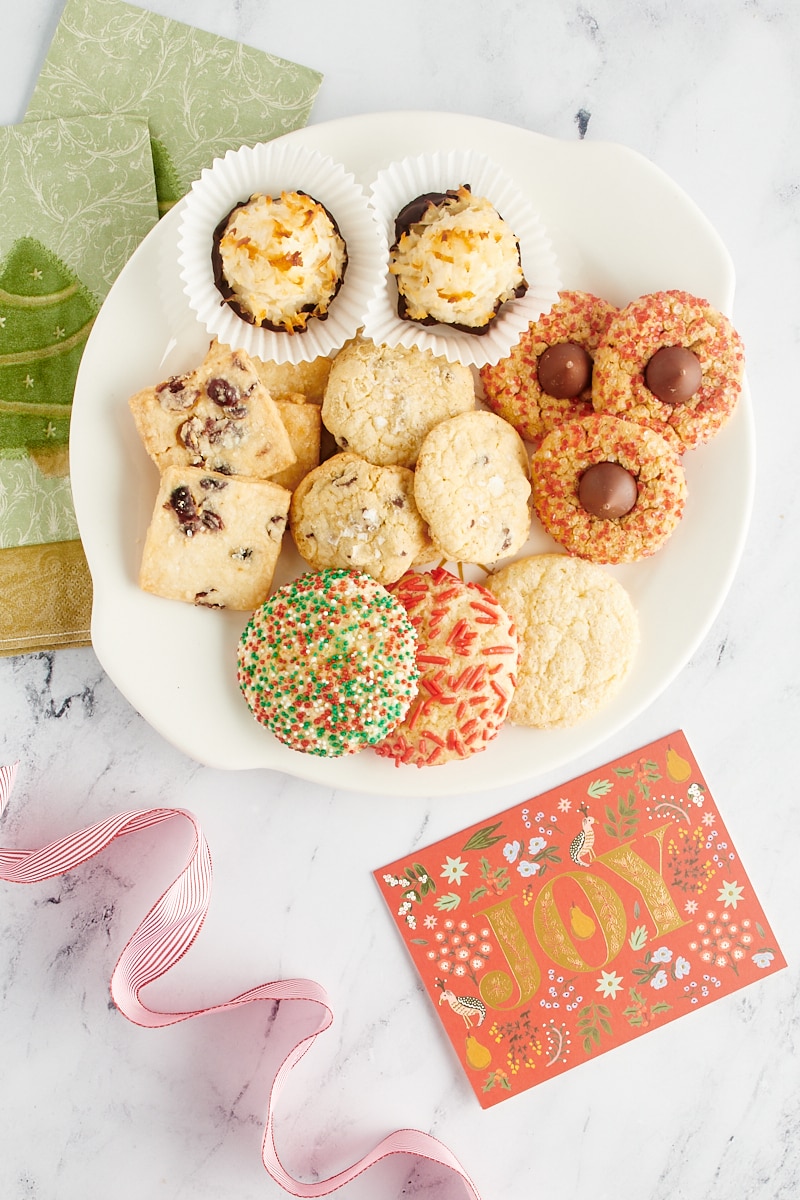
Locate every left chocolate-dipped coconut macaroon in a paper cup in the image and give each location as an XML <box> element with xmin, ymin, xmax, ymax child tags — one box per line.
<box><xmin>212</xmin><ymin>192</ymin><xmax>347</xmax><ymax>334</ymax></box>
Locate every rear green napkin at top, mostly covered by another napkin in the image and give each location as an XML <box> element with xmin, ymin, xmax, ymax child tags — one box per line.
<box><xmin>26</xmin><ymin>0</ymin><xmax>321</xmax><ymax>212</ymax></box>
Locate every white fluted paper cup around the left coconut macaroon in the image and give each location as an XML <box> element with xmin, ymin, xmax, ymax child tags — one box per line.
<box><xmin>178</xmin><ymin>139</ymin><xmax>384</xmax><ymax>362</ymax></box>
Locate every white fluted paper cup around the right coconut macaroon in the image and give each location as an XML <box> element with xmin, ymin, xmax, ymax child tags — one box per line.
<box><xmin>363</xmin><ymin>150</ymin><xmax>561</xmax><ymax>367</ymax></box>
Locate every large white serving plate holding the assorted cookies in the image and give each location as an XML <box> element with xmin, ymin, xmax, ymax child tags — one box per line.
<box><xmin>70</xmin><ymin>113</ymin><xmax>754</xmax><ymax>796</ymax></box>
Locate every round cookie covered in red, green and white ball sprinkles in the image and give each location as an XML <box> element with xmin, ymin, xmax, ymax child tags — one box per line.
<box><xmin>237</xmin><ymin>569</ymin><xmax>419</xmax><ymax>757</ymax></box>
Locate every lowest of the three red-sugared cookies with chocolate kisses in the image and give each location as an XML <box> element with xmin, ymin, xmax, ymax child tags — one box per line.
<box><xmin>531</xmin><ymin>415</ymin><xmax>686</xmax><ymax>563</ymax></box>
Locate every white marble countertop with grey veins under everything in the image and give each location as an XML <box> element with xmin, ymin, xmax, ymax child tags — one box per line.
<box><xmin>0</xmin><ymin>0</ymin><xmax>800</xmax><ymax>1200</ymax></box>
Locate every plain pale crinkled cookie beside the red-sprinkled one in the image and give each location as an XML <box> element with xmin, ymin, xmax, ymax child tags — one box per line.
<box><xmin>486</xmin><ymin>554</ymin><xmax>639</xmax><ymax>728</ymax></box>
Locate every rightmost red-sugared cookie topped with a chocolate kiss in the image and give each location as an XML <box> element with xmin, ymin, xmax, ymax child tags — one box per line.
<box><xmin>593</xmin><ymin>290</ymin><xmax>745</xmax><ymax>449</ymax></box>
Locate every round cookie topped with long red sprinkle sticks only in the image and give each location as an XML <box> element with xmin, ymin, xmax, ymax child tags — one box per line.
<box><xmin>375</xmin><ymin>568</ymin><xmax>519</xmax><ymax>767</ymax></box>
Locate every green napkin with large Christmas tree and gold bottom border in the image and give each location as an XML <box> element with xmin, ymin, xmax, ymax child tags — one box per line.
<box><xmin>0</xmin><ymin>114</ymin><xmax>158</xmax><ymax>653</ymax></box>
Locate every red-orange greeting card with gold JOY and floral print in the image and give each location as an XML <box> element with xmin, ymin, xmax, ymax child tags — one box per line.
<box><xmin>374</xmin><ymin>732</ymin><xmax>786</xmax><ymax>1108</ymax></box>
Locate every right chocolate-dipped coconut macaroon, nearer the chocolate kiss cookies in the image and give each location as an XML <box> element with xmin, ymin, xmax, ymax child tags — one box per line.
<box><xmin>389</xmin><ymin>184</ymin><xmax>528</xmax><ymax>334</ymax></box>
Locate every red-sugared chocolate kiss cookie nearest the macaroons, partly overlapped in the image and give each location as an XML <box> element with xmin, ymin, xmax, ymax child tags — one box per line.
<box><xmin>480</xmin><ymin>292</ymin><xmax>618</xmax><ymax>445</ymax></box>
